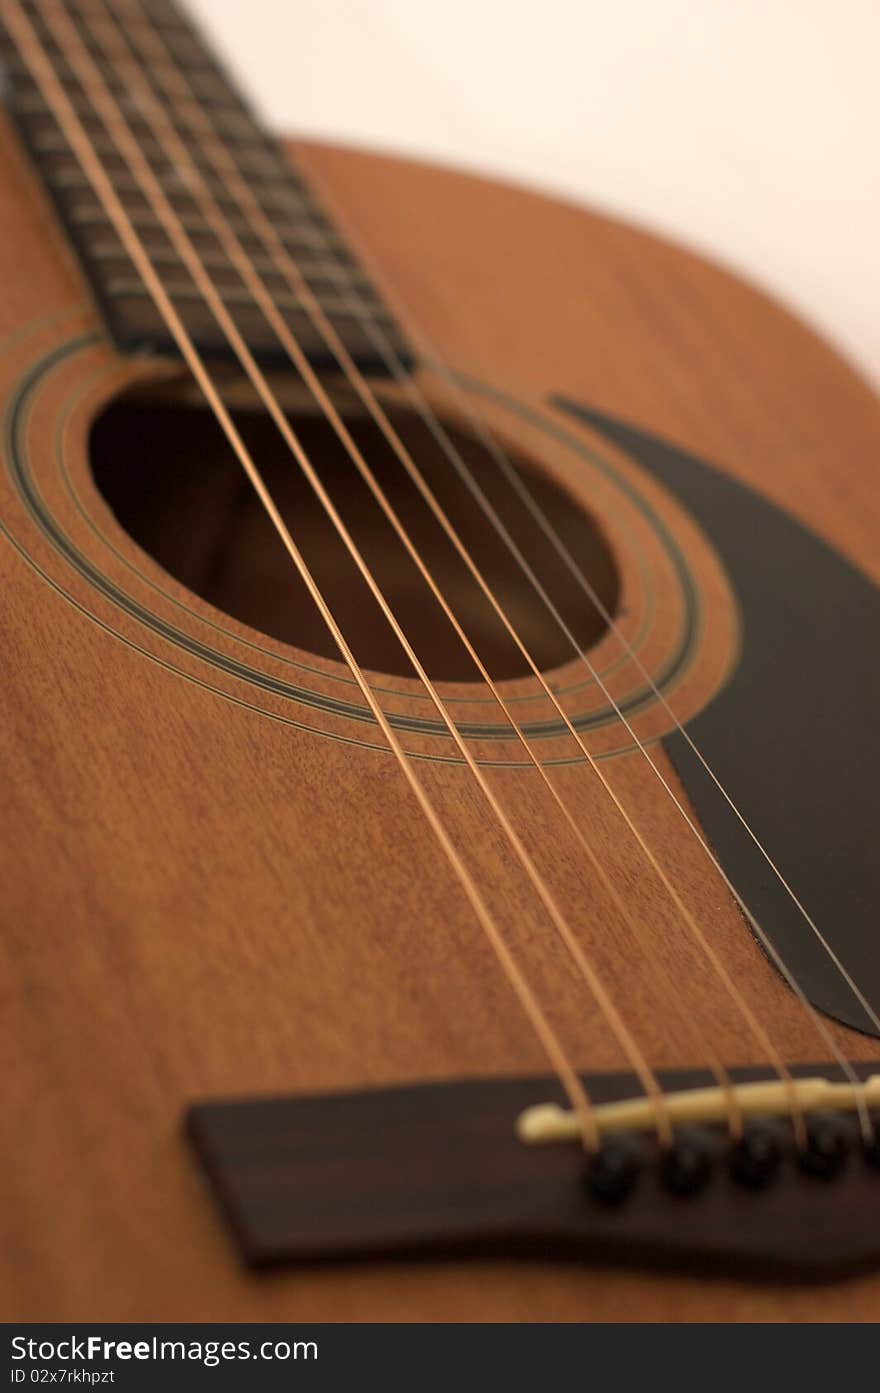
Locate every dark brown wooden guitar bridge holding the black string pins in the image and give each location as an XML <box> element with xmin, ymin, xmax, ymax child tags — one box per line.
<box><xmin>187</xmin><ymin>1064</ymin><xmax>880</xmax><ymax>1280</ymax></box>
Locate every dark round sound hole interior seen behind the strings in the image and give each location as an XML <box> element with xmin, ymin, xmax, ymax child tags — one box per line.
<box><xmin>91</xmin><ymin>398</ymin><xmax>618</xmax><ymax>681</ymax></box>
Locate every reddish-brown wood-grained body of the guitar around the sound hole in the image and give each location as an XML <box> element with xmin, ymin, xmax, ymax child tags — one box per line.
<box><xmin>0</xmin><ymin>114</ymin><xmax>880</xmax><ymax>1321</ymax></box>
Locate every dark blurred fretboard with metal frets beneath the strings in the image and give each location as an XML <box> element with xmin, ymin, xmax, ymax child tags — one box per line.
<box><xmin>0</xmin><ymin>0</ymin><xmax>411</xmax><ymax>372</ymax></box>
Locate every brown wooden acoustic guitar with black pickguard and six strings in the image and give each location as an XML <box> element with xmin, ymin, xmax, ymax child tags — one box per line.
<box><xmin>0</xmin><ymin>0</ymin><xmax>880</xmax><ymax>1321</ymax></box>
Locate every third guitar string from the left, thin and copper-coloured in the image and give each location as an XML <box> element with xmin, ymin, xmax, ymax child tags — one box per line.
<box><xmin>98</xmin><ymin>4</ymin><xmax>774</xmax><ymax>1139</ymax></box>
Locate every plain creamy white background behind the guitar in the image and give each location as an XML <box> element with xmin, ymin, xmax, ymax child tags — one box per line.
<box><xmin>183</xmin><ymin>0</ymin><xmax>880</xmax><ymax>386</ymax></box>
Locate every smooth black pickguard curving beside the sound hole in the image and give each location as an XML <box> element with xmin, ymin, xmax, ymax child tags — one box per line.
<box><xmin>553</xmin><ymin>398</ymin><xmax>880</xmax><ymax>1035</ymax></box>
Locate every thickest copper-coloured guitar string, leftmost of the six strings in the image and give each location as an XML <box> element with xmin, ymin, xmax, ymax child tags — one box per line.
<box><xmin>4</xmin><ymin>0</ymin><xmax>599</xmax><ymax>1151</ymax></box>
